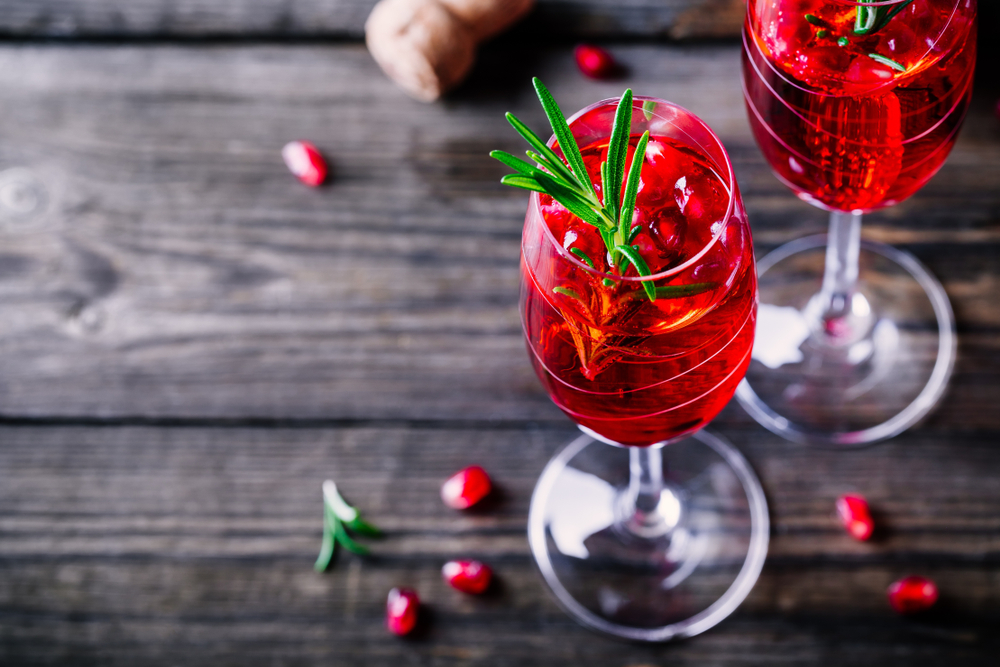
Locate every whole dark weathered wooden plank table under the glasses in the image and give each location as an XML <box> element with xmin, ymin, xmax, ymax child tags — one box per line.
<box><xmin>0</xmin><ymin>0</ymin><xmax>1000</xmax><ymax>667</ymax></box>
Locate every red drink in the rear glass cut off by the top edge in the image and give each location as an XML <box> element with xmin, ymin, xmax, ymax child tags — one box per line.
<box><xmin>743</xmin><ymin>0</ymin><xmax>976</xmax><ymax>211</ymax></box>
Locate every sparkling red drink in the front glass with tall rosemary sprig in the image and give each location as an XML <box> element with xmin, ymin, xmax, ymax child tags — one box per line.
<box><xmin>521</xmin><ymin>100</ymin><xmax>757</xmax><ymax>446</ymax></box>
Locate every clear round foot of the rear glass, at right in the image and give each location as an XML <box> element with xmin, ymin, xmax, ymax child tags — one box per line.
<box><xmin>736</xmin><ymin>234</ymin><xmax>956</xmax><ymax>447</ymax></box>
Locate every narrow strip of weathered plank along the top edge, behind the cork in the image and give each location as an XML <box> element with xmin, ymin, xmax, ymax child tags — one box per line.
<box><xmin>0</xmin><ymin>0</ymin><xmax>745</xmax><ymax>39</ymax></box>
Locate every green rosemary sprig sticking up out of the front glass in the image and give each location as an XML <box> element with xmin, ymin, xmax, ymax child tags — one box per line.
<box><xmin>490</xmin><ymin>78</ymin><xmax>657</xmax><ymax>301</ymax></box>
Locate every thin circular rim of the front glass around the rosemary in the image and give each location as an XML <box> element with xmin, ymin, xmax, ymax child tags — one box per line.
<box><xmin>528</xmin><ymin>95</ymin><xmax>736</xmax><ymax>283</ymax></box>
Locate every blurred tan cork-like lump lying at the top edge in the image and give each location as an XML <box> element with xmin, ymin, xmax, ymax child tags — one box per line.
<box><xmin>365</xmin><ymin>0</ymin><xmax>534</xmax><ymax>102</ymax></box>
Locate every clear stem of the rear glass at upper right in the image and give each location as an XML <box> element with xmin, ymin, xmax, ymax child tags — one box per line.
<box><xmin>820</xmin><ymin>211</ymin><xmax>861</xmax><ymax>321</ymax></box>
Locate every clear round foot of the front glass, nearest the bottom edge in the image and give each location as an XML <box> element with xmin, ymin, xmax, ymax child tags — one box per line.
<box><xmin>528</xmin><ymin>431</ymin><xmax>769</xmax><ymax>642</ymax></box>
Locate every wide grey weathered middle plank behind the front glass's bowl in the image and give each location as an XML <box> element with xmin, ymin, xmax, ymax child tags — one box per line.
<box><xmin>0</xmin><ymin>45</ymin><xmax>1000</xmax><ymax>428</ymax></box>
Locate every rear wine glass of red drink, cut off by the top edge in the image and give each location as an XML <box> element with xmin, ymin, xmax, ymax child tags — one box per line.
<box><xmin>737</xmin><ymin>0</ymin><xmax>976</xmax><ymax>446</ymax></box>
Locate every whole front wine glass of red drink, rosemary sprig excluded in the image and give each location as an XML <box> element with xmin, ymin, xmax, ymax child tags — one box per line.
<box><xmin>520</xmin><ymin>97</ymin><xmax>768</xmax><ymax>641</ymax></box>
